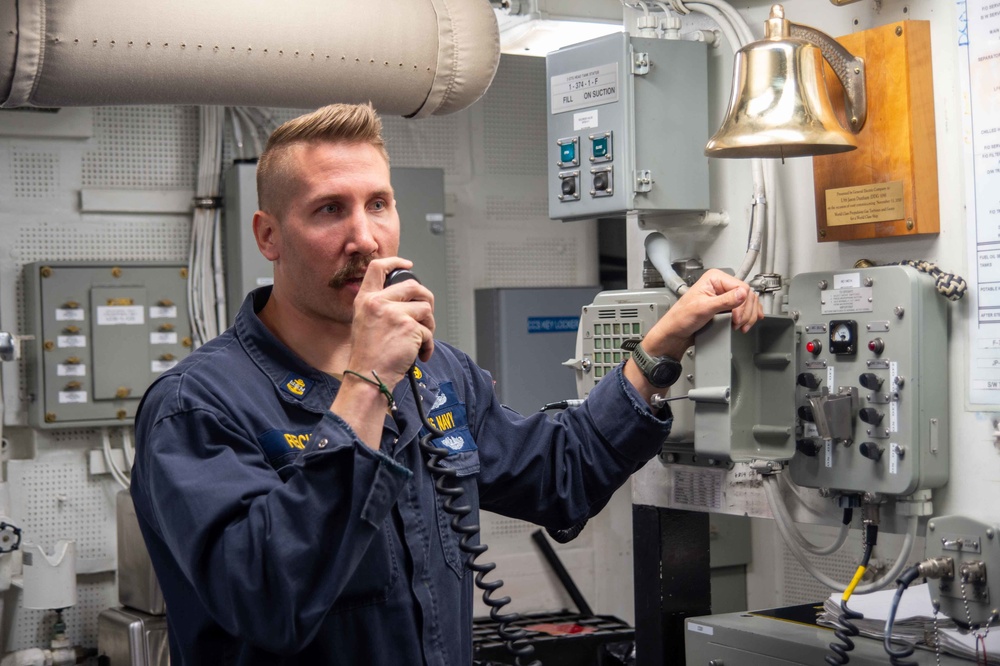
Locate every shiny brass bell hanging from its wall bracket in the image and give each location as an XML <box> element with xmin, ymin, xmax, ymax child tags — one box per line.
<box><xmin>705</xmin><ymin>5</ymin><xmax>865</xmax><ymax>159</ymax></box>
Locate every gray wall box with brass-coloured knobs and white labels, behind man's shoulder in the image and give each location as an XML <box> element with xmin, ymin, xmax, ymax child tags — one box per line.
<box><xmin>24</xmin><ymin>262</ymin><xmax>192</xmax><ymax>428</ymax></box>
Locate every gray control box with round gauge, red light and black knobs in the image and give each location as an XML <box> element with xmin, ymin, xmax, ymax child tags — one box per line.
<box><xmin>788</xmin><ymin>266</ymin><xmax>949</xmax><ymax>496</ymax></box>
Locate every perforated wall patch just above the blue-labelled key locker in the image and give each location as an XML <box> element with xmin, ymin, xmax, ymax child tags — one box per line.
<box><xmin>485</xmin><ymin>237</ymin><xmax>579</xmax><ymax>287</ymax></box>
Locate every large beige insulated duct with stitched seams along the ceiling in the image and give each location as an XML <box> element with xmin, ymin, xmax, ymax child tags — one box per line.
<box><xmin>0</xmin><ymin>0</ymin><xmax>500</xmax><ymax>117</ymax></box>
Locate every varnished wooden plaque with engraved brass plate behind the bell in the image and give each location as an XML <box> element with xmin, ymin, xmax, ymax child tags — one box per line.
<box><xmin>813</xmin><ymin>21</ymin><xmax>940</xmax><ymax>241</ymax></box>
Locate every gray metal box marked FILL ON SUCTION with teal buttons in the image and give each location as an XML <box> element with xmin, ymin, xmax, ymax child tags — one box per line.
<box><xmin>545</xmin><ymin>33</ymin><xmax>709</xmax><ymax>220</ymax></box>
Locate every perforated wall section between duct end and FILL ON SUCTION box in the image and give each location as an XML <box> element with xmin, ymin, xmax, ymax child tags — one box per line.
<box><xmin>483</xmin><ymin>55</ymin><xmax>548</xmax><ymax>175</ymax></box>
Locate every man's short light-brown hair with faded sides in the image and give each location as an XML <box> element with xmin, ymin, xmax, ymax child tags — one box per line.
<box><xmin>257</xmin><ymin>103</ymin><xmax>389</xmax><ymax>217</ymax></box>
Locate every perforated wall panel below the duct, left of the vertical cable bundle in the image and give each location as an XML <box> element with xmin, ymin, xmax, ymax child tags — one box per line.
<box><xmin>82</xmin><ymin>106</ymin><xmax>198</xmax><ymax>190</ymax></box>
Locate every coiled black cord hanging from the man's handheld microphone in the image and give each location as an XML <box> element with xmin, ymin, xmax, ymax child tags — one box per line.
<box><xmin>406</xmin><ymin>368</ymin><xmax>541</xmax><ymax>666</ymax></box>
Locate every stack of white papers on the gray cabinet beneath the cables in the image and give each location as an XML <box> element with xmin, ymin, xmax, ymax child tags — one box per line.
<box><xmin>816</xmin><ymin>583</ymin><xmax>1000</xmax><ymax>664</ymax></box>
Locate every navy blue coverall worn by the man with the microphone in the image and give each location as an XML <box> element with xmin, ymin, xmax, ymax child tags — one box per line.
<box><xmin>131</xmin><ymin>287</ymin><xmax>670</xmax><ymax>666</ymax></box>
